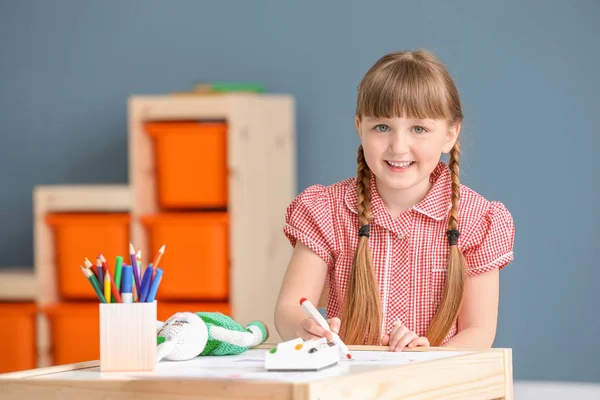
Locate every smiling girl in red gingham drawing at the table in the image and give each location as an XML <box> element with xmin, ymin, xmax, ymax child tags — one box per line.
<box><xmin>275</xmin><ymin>50</ymin><xmax>514</xmax><ymax>351</ymax></box>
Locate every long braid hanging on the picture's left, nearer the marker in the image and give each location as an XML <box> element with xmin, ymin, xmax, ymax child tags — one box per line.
<box><xmin>340</xmin><ymin>145</ymin><xmax>382</xmax><ymax>345</ymax></box>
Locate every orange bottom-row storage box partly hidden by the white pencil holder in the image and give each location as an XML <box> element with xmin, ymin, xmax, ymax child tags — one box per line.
<box><xmin>44</xmin><ymin>304</ymin><xmax>100</xmax><ymax>365</ymax></box>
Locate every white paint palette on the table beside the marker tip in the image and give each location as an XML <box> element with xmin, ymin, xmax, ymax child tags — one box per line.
<box><xmin>265</xmin><ymin>338</ymin><xmax>340</xmax><ymax>371</ymax></box>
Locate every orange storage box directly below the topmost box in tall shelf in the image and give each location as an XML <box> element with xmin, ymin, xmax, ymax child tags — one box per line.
<box><xmin>140</xmin><ymin>212</ymin><xmax>229</xmax><ymax>301</ymax></box>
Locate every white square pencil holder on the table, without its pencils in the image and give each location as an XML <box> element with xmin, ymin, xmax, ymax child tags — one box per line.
<box><xmin>100</xmin><ymin>301</ymin><xmax>156</xmax><ymax>372</ymax></box>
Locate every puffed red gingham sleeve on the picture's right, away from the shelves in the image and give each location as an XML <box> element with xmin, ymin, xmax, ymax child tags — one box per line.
<box><xmin>463</xmin><ymin>201</ymin><xmax>515</xmax><ymax>275</ymax></box>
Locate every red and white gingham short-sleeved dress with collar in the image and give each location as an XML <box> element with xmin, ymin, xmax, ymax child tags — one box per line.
<box><xmin>284</xmin><ymin>162</ymin><xmax>514</xmax><ymax>343</ymax></box>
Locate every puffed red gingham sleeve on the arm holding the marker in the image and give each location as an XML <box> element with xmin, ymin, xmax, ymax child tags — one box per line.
<box><xmin>283</xmin><ymin>185</ymin><xmax>335</xmax><ymax>268</ymax></box>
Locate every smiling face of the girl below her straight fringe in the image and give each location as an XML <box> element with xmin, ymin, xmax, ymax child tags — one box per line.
<box><xmin>356</xmin><ymin>117</ymin><xmax>460</xmax><ymax>205</ymax></box>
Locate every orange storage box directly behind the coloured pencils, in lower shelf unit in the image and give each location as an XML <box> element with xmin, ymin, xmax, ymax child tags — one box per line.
<box><xmin>46</xmin><ymin>213</ymin><xmax>130</xmax><ymax>300</ymax></box>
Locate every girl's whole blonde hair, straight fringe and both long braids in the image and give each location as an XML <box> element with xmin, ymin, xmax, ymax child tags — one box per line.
<box><xmin>340</xmin><ymin>50</ymin><xmax>465</xmax><ymax>346</ymax></box>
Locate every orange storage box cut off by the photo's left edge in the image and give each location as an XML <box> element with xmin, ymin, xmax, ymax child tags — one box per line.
<box><xmin>0</xmin><ymin>303</ymin><xmax>37</xmax><ymax>373</ymax></box>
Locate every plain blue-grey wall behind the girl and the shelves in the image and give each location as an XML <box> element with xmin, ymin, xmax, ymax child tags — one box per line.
<box><xmin>0</xmin><ymin>0</ymin><xmax>600</xmax><ymax>382</ymax></box>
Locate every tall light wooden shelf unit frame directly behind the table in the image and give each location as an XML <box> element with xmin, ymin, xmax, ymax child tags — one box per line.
<box><xmin>128</xmin><ymin>93</ymin><xmax>296</xmax><ymax>341</ymax></box>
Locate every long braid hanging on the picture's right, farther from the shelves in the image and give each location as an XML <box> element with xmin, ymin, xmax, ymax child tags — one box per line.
<box><xmin>427</xmin><ymin>140</ymin><xmax>466</xmax><ymax>346</ymax></box>
